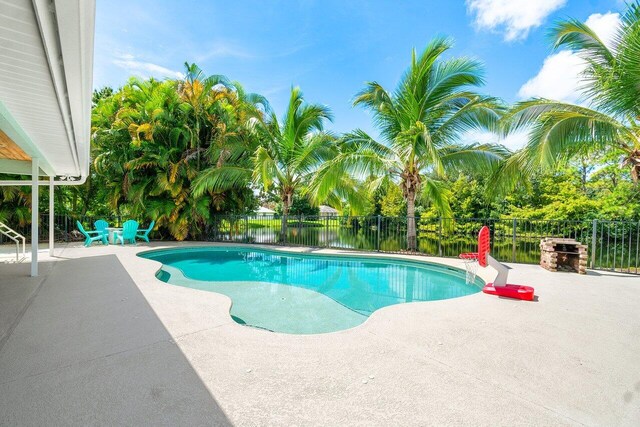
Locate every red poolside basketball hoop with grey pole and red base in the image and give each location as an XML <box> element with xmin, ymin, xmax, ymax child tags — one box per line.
<box><xmin>460</xmin><ymin>225</ymin><xmax>534</xmax><ymax>301</ymax></box>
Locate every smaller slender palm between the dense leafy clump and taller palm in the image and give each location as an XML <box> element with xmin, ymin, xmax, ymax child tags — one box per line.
<box><xmin>194</xmin><ymin>87</ymin><xmax>335</xmax><ymax>239</ymax></box>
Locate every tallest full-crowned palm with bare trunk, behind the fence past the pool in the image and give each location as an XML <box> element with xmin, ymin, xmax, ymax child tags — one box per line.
<box><xmin>315</xmin><ymin>38</ymin><xmax>505</xmax><ymax>250</ymax></box>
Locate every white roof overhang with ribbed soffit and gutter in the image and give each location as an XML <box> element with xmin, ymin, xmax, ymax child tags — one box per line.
<box><xmin>0</xmin><ymin>0</ymin><xmax>95</xmax><ymax>177</ymax></box>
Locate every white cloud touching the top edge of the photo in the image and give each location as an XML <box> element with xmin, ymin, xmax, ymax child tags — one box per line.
<box><xmin>466</xmin><ymin>0</ymin><xmax>567</xmax><ymax>41</ymax></box>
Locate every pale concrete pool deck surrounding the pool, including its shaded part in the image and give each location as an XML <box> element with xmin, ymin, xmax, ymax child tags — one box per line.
<box><xmin>0</xmin><ymin>243</ymin><xmax>640</xmax><ymax>426</ymax></box>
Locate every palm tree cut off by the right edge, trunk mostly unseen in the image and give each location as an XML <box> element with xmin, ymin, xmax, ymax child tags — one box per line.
<box><xmin>497</xmin><ymin>1</ymin><xmax>640</xmax><ymax>186</ymax></box>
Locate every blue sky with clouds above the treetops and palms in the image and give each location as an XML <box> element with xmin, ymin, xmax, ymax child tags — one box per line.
<box><xmin>94</xmin><ymin>0</ymin><xmax>624</xmax><ymax>145</ymax></box>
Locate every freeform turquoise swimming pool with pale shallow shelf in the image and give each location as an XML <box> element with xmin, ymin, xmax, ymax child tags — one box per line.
<box><xmin>139</xmin><ymin>247</ymin><xmax>484</xmax><ymax>334</ymax></box>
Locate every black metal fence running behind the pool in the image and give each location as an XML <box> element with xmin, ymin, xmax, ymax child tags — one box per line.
<box><xmin>0</xmin><ymin>215</ymin><xmax>640</xmax><ymax>274</ymax></box>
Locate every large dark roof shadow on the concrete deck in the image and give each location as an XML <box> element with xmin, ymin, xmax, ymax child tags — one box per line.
<box><xmin>0</xmin><ymin>255</ymin><xmax>231</xmax><ymax>426</ymax></box>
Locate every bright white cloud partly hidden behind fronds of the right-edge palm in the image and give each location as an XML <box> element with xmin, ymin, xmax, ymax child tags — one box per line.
<box><xmin>518</xmin><ymin>12</ymin><xmax>620</xmax><ymax>102</ymax></box>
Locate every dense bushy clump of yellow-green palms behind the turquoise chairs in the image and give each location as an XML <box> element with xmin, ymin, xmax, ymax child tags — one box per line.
<box><xmin>92</xmin><ymin>64</ymin><xmax>266</xmax><ymax>240</ymax></box>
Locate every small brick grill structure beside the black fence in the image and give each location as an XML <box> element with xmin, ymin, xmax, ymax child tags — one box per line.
<box><xmin>540</xmin><ymin>237</ymin><xmax>588</xmax><ymax>274</ymax></box>
